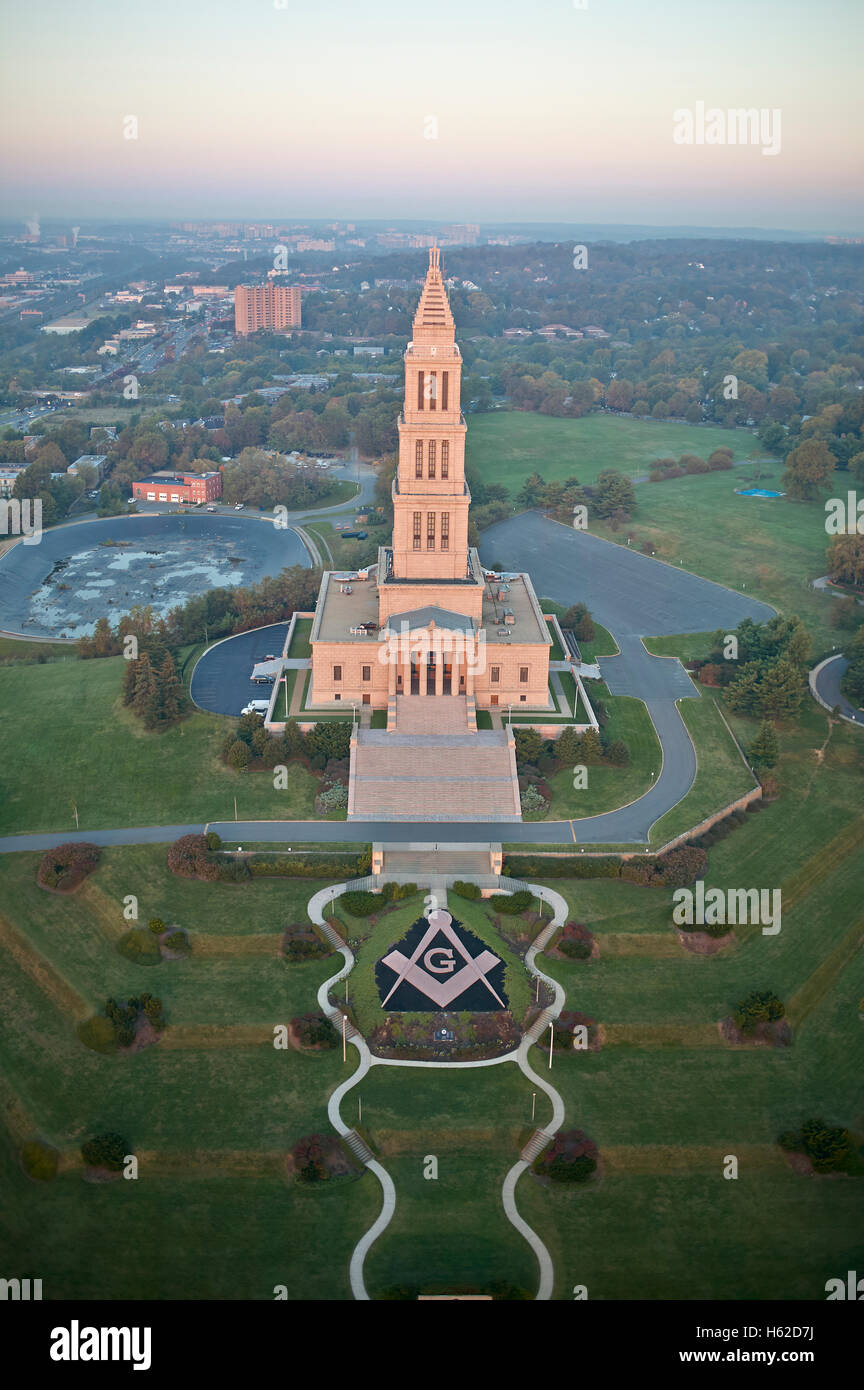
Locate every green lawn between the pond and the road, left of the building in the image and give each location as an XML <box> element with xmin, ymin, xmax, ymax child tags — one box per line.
<box><xmin>0</xmin><ymin>657</ymin><xmax>317</xmax><ymax>834</ymax></box>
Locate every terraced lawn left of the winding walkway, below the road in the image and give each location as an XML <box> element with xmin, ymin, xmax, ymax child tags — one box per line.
<box><xmin>0</xmin><ymin>847</ymin><xmax>379</xmax><ymax>1300</ymax></box>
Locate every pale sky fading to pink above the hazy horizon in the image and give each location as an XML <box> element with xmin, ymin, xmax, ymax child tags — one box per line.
<box><xmin>0</xmin><ymin>0</ymin><xmax>864</xmax><ymax>232</ymax></box>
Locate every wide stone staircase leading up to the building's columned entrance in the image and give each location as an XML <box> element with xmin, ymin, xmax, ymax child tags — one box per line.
<box><xmin>349</xmin><ymin>695</ymin><xmax>522</xmax><ymax>821</ymax></box>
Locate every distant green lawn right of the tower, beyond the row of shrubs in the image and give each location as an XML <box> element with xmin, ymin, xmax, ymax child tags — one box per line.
<box><xmin>467</xmin><ymin>410</ymin><xmax>764</xmax><ymax>494</ymax></box>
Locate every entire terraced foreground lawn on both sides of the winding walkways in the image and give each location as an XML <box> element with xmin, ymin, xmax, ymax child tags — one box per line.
<box><xmin>0</xmin><ymin>702</ymin><xmax>864</xmax><ymax>1300</ymax></box>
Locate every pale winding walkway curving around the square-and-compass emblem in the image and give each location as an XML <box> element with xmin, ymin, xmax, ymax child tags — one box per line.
<box><xmin>307</xmin><ymin>883</ymin><xmax>567</xmax><ymax>1301</ymax></box>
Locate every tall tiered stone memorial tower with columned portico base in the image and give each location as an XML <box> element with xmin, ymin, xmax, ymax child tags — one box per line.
<box><xmin>308</xmin><ymin>247</ymin><xmax>551</xmax><ymax>819</ymax></box>
